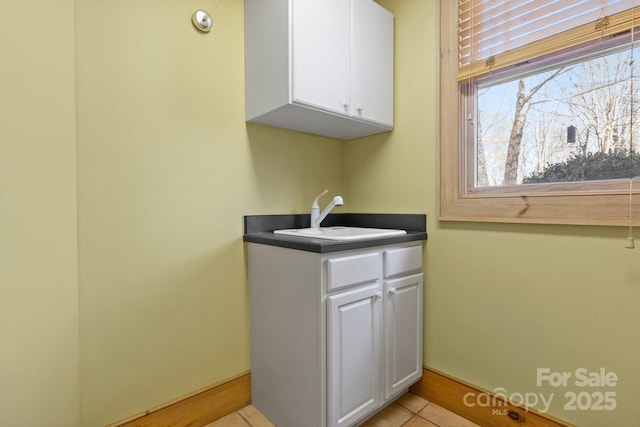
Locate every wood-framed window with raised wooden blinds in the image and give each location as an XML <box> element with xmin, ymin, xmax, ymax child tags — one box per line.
<box><xmin>440</xmin><ymin>0</ymin><xmax>640</xmax><ymax>225</ymax></box>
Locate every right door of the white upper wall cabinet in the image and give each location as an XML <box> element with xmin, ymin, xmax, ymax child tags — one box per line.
<box><xmin>351</xmin><ymin>0</ymin><xmax>393</xmax><ymax>126</ymax></box>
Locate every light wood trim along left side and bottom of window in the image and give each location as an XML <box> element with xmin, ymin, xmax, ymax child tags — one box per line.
<box><xmin>439</xmin><ymin>0</ymin><xmax>640</xmax><ymax>226</ymax></box>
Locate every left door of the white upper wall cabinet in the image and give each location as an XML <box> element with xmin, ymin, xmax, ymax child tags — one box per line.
<box><xmin>291</xmin><ymin>0</ymin><xmax>351</xmax><ymax>114</ymax></box>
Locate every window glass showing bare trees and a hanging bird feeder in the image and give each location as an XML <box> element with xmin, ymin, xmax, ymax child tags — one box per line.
<box><xmin>463</xmin><ymin>43</ymin><xmax>640</xmax><ymax>187</ymax></box>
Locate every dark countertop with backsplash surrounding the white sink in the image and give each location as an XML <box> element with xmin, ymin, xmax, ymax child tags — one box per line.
<box><xmin>243</xmin><ymin>213</ymin><xmax>427</xmax><ymax>253</ymax></box>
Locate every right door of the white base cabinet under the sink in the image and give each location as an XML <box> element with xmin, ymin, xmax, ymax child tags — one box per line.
<box><xmin>384</xmin><ymin>273</ymin><xmax>423</xmax><ymax>399</ymax></box>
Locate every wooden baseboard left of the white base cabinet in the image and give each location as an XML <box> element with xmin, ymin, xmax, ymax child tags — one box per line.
<box><xmin>107</xmin><ymin>372</ymin><xmax>251</xmax><ymax>427</ymax></box>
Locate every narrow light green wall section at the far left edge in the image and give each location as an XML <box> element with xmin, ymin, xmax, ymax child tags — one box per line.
<box><xmin>0</xmin><ymin>0</ymin><xmax>78</xmax><ymax>427</ymax></box>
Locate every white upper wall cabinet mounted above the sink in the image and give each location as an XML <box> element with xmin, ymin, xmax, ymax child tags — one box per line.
<box><xmin>245</xmin><ymin>0</ymin><xmax>393</xmax><ymax>139</ymax></box>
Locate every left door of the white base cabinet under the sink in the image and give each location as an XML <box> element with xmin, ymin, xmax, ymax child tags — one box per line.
<box><xmin>327</xmin><ymin>282</ymin><xmax>382</xmax><ymax>427</ymax></box>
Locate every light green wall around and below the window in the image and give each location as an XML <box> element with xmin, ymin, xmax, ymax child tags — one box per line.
<box><xmin>345</xmin><ymin>0</ymin><xmax>640</xmax><ymax>427</ymax></box>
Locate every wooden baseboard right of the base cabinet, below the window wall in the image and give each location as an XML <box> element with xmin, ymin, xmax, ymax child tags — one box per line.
<box><xmin>410</xmin><ymin>367</ymin><xmax>575</xmax><ymax>427</ymax></box>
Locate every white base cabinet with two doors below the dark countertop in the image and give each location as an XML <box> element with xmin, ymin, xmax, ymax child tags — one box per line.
<box><xmin>248</xmin><ymin>242</ymin><xmax>423</xmax><ymax>427</ymax></box>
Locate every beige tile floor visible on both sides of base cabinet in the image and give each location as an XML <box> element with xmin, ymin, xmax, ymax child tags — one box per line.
<box><xmin>205</xmin><ymin>393</ymin><xmax>479</xmax><ymax>427</ymax></box>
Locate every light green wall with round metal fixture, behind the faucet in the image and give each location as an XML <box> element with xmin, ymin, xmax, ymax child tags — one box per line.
<box><xmin>76</xmin><ymin>0</ymin><xmax>343</xmax><ymax>426</ymax></box>
